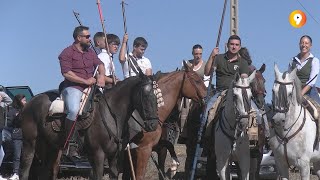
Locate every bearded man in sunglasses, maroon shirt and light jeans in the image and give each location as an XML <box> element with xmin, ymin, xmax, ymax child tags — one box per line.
<box><xmin>59</xmin><ymin>26</ymin><xmax>105</xmax><ymax>157</ymax></box>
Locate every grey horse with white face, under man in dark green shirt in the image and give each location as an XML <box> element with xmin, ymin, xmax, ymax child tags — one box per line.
<box><xmin>215</xmin><ymin>72</ymin><xmax>256</xmax><ymax>180</ymax></box>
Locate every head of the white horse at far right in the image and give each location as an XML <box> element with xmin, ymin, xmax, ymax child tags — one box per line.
<box><xmin>272</xmin><ymin>64</ymin><xmax>302</xmax><ymax>113</ymax></box>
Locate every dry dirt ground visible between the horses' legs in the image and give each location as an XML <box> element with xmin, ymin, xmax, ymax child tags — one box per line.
<box><xmin>55</xmin><ymin>144</ymin><xmax>318</xmax><ymax>180</ymax></box>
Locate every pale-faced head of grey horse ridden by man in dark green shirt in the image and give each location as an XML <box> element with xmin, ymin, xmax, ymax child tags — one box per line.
<box><xmin>228</xmin><ymin>71</ymin><xmax>256</xmax><ymax>132</ymax></box>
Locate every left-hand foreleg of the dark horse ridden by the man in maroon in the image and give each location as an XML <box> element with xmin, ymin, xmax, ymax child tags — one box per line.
<box><xmin>89</xmin><ymin>148</ymin><xmax>105</xmax><ymax>180</ymax></box>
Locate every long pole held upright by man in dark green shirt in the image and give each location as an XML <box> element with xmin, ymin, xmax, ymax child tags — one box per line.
<box><xmin>190</xmin><ymin>0</ymin><xmax>227</xmax><ymax>180</ymax></box>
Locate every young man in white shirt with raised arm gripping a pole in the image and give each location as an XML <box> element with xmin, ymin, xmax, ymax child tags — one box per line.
<box><xmin>119</xmin><ymin>34</ymin><xmax>152</xmax><ymax>78</ymax></box>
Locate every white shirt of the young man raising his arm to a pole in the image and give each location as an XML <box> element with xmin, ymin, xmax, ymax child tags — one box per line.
<box><xmin>121</xmin><ymin>53</ymin><xmax>152</xmax><ymax>78</ymax></box>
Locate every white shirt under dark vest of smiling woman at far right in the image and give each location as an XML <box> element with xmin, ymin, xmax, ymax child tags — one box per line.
<box><xmin>293</xmin><ymin>53</ymin><xmax>319</xmax><ymax>86</ymax></box>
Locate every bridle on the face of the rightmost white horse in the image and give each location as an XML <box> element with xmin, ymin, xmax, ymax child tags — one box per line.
<box><xmin>272</xmin><ymin>80</ymin><xmax>294</xmax><ymax>113</ymax></box>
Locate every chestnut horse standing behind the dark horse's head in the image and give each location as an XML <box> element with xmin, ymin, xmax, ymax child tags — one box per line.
<box><xmin>124</xmin><ymin>62</ymin><xmax>206</xmax><ymax>180</ymax></box>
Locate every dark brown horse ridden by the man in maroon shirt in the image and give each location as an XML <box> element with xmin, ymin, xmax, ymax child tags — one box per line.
<box><xmin>20</xmin><ymin>74</ymin><xmax>158</xmax><ymax>180</ymax></box>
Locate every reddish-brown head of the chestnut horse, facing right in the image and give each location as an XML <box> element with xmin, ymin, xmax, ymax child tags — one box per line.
<box><xmin>181</xmin><ymin>61</ymin><xmax>207</xmax><ymax>102</ymax></box>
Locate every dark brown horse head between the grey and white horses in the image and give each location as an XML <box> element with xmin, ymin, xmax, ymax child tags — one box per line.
<box><xmin>250</xmin><ymin>64</ymin><xmax>267</xmax><ymax>109</ymax></box>
